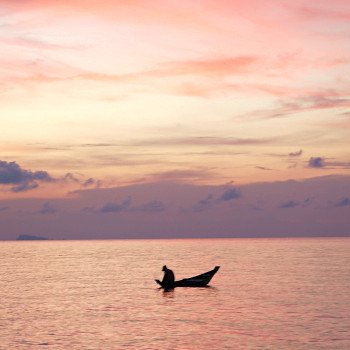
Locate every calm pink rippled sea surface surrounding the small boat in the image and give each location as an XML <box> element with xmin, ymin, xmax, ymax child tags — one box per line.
<box><xmin>0</xmin><ymin>238</ymin><xmax>350</xmax><ymax>350</ymax></box>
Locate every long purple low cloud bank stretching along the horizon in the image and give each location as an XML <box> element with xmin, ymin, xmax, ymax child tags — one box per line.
<box><xmin>0</xmin><ymin>176</ymin><xmax>350</xmax><ymax>239</ymax></box>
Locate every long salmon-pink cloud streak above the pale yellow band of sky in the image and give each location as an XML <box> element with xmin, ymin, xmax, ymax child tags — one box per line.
<box><xmin>0</xmin><ymin>52</ymin><xmax>260</xmax><ymax>99</ymax></box>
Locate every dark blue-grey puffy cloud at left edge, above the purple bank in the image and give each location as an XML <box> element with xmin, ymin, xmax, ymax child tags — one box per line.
<box><xmin>0</xmin><ymin>161</ymin><xmax>54</xmax><ymax>192</ymax></box>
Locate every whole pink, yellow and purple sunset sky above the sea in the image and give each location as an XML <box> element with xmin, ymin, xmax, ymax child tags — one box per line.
<box><xmin>0</xmin><ymin>0</ymin><xmax>350</xmax><ymax>239</ymax></box>
